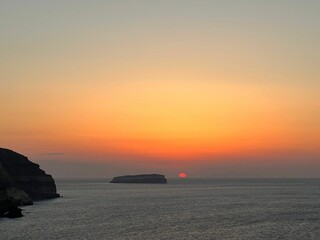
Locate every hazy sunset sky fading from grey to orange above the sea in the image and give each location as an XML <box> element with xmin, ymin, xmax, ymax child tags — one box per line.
<box><xmin>0</xmin><ymin>0</ymin><xmax>320</xmax><ymax>178</ymax></box>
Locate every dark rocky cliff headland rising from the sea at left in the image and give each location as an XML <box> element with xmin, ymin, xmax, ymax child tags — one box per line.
<box><xmin>0</xmin><ymin>148</ymin><xmax>60</xmax><ymax>217</ymax></box>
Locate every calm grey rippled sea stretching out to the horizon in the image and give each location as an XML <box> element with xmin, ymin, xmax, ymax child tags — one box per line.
<box><xmin>0</xmin><ymin>179</ymin><xmax>320</xmax><ymax>240</ymax></box>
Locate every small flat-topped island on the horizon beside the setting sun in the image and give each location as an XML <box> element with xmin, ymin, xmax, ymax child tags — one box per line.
<box><xmin>110</xmin><ymin>174</ymin><xmax>167</xmax><ymax>183</ymax></box>
